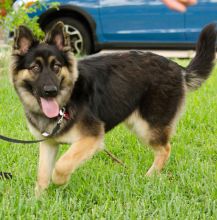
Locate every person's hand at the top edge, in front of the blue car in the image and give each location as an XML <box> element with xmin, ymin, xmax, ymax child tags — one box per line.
<box><xmin>162</xmin><ymin>0</ymin><xmax>197</xmax><ymax>12</ymax></box>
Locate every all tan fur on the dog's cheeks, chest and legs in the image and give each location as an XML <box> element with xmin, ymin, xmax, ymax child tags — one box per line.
<box><xmin>13</xmin><ymin>53</ymin><xmax>183</xmax><ymax>196</ymax></box>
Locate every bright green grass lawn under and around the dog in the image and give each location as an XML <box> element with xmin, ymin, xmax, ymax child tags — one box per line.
<box><xmin>0</xmin><ymin>49</ymin><xmax>217</xmax><ymax>220</ymax></box>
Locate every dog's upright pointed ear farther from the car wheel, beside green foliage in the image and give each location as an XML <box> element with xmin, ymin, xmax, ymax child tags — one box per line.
<box><xmin>13</xmin><ymin>25</ymin><xmax>38</xmax><ymax>55</ymax></box>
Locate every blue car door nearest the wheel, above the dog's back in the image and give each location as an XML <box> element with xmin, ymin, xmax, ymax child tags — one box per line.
<box><xmin>99</xmin><ymin>0</ymin><xmax>185</xmax><ymax>43</ymax></box>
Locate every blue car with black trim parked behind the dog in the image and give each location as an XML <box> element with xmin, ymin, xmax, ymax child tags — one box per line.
<box><xmin>15</xmin><ymin>0</ymin><xmax>217</xmax><ymax>54</ymax></box>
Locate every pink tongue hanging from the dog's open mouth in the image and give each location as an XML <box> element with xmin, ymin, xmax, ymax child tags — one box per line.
<box><xmin>40</xmin><ymin>97</ymin><xmax>60</xmax><ymax>118</ymax></box>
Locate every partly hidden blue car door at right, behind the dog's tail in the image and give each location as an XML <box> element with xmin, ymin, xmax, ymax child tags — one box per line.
<box><xmin>185</xmin><ymin>0</ymin><xmax>217</xmax><ymax>43</ymax></box>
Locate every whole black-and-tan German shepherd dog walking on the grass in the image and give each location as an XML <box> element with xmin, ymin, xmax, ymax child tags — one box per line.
<box><xmin>12</xmin><ymin>22</ymin><xmax>216</xmax><ymax>196</ymax></box>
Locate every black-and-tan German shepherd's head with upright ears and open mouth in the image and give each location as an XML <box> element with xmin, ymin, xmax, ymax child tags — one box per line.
<box><xmin>12</xmin><ymin>22</ymin><xmax>77</xmax><ymax>118</ymax></box>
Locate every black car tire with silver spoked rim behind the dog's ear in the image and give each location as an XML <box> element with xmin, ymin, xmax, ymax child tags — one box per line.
<box><xmin>43</xmin><ymin>17</ymin><xmax>93</xmax><ymax>56</ymax></box>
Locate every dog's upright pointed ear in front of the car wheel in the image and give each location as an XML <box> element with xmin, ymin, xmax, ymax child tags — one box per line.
<box><xmin>44</xmin><ymin>21</ymin><xmax>71</xmax><ymax>51</ymax></box>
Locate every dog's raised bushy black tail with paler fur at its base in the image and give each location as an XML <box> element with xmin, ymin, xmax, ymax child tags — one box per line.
<box><xmin>185</xmin><ymin>23</ymin><xmax>217</xmax><ymax>91</ymax></box>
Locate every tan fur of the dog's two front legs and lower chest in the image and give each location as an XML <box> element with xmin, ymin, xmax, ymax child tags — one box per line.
<box><xmin>29</xmin><ymin>117</ymin><xmax>104</xmax><ymax>197</ymax></box>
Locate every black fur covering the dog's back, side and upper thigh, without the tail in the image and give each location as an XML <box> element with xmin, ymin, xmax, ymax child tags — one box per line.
<box><xmin>75</xmin><ymin>51</ymin><xmax>184</xmax><ymax>131</ymax></box>
